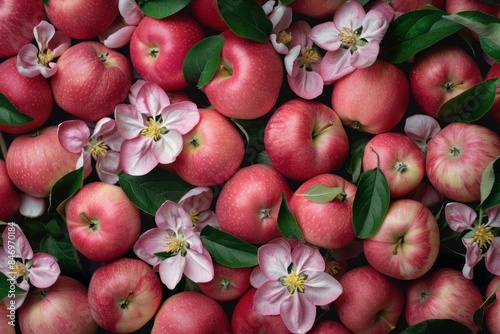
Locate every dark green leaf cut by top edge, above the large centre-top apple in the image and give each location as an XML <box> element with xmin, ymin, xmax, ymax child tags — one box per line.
<box><xmin>217</xmin><ymin>0</ymin><xmax>273</xmax><ymax>43</ymax></box>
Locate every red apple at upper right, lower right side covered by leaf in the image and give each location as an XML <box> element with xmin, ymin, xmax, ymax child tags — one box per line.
<box><xmin>409</xmin><ymin>44</ymin><xmax>483</xmax><ymax>117</ymax></box>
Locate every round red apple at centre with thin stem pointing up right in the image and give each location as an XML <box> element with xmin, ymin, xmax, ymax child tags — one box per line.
<box><xmin>264</xmin><ymin>99</ymin><xmax>349</xmax><ymax>181</ymax></box>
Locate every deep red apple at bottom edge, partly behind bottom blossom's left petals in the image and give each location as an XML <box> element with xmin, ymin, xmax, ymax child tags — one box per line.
<box><xmin>231</xmin><ymin>288</ymin><xmax>291</xmax><ymax>334</ymax></box>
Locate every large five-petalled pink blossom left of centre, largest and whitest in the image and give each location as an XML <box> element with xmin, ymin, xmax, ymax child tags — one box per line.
<box><xmin>115</xmin><ymin>82</ymin><xmax>200</xmax><ymax>175</ymax></box>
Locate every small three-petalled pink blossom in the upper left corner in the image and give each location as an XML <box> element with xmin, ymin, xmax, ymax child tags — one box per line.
<box><xmin>17</xmin><ymin>21</ymin><xmax>71</xmax><ymax>78</ymax></box>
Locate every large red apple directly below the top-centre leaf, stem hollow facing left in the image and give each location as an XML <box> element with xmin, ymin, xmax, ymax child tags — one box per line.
<box><xmin>203</xmin><ymin>30</ymin><xmax>284</xmax><ymax>119</ymax></box>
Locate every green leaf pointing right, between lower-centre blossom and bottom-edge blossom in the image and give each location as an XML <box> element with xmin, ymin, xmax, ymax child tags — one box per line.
<box><xmin>200</xmin><ymin>225</ymin><xmax>258</xmax><ymax>268</ymax></box>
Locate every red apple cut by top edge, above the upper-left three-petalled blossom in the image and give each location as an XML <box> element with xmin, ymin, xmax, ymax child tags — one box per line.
<box><xmin>45</xmin><ymin>0</ymin><xmax>118</xmax><ymax>39</ymax></box>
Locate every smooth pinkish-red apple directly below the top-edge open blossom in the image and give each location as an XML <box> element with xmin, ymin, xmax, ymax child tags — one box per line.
<box><xmin>332</xmin><ymin>60</ymin><xmax>410</xmax><ymax>134</ymax></box>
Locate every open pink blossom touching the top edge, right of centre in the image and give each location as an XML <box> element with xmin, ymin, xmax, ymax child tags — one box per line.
<box><xmin>310</xmin><ymin>0</ymin><xmax>390</xmax><ymax>83</ymax></box>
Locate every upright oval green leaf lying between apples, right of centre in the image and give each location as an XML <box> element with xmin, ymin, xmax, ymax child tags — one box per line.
<box><xmin>352</xmin><ymin>167</ymin><xmax>390</xmax><ymax>239</ymax></box>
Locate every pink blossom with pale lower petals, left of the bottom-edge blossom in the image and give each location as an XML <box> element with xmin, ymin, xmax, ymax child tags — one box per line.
<box><xmin>134</xmin><ymin>201</ymin><xmax>214</xmax><ymax>290</ymax></box>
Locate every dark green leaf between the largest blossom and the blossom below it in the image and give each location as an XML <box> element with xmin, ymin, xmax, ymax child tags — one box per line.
<box><xmin>118</xmin><ymin>167</ymin><xmax>194</xmax><ymax>216</ymax></box>
